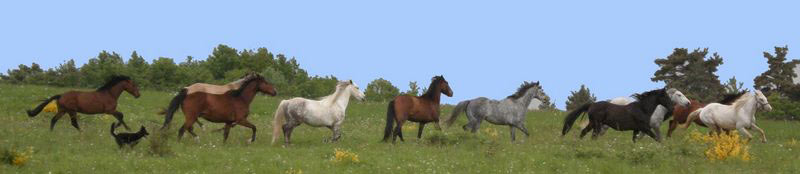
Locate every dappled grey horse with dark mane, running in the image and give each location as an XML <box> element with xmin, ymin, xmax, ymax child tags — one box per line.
<box><xmin>445</xmin><ymin>81</ymin><xmax>545</xmax><ymax>142</ymax></box>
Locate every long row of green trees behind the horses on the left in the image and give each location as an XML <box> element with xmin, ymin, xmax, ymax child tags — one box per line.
<box><xmin>0</xmin><ymin>45</ymin><xmax>337</xmax><ymax>97</ymax></box>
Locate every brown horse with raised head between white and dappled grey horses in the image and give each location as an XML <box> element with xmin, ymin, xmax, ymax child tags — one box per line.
<box><xmin>383</xmin><ymin>76</ymin><xmax>453</xmax><ymax>142</ymax></box>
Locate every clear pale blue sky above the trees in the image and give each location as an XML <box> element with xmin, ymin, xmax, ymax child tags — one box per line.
<box><xmin>0</xmin><ymin>1</ymin><xmax>800</xmax><ymax>108</ymax></box>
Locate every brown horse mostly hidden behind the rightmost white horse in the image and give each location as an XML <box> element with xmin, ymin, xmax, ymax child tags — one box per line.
<box><xmin>667</xmin><ymin>91</ymin><xmax>747</xmax><ymax>137</ymax></box>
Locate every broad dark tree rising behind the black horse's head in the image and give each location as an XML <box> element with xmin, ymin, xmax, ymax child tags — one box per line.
<box><xmin>650</xmin><ymin>48</ymin><xmax>724</xmax><ymax>102</ymax></box>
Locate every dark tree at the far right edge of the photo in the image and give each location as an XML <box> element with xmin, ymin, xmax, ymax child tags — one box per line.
<box><xmin>753</xmin><ymin>46</ymin><xmax>800</xmax><ymax>95</ymax></box>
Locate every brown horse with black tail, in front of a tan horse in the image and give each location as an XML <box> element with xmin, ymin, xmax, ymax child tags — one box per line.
<box><xmin>162</xmin><ymin>75</ymin><xmax>277</xmax><ymax>142</ymax></box>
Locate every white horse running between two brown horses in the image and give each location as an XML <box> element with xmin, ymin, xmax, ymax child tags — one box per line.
<box><xmin>272</xmin><ymin>80</ymin><xmax>364</xmax><ymax>145</ymax></box>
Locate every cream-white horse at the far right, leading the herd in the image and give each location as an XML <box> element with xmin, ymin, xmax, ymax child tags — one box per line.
<box><xmin>681</xmin><ymin>90</ymin><xmax>772</xmax><ymax>143</ymax></box>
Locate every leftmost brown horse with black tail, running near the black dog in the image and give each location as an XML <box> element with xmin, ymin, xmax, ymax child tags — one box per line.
<box><xmin>27</xmin><ymin>76</ymin><xmax>139</xmax><ymax>131</ymax></box>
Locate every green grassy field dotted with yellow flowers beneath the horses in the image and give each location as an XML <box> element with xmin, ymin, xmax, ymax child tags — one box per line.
<box><xmin>0</xmin><ymin>84</ymin><xmax>800</xmax><ymax>173</ymax></box>
